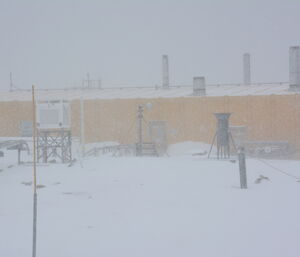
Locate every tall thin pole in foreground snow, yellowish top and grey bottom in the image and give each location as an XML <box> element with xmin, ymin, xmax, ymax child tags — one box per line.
<box><xmin>32</xmin><ymin>85</ymin><xmax>37</xmax><ymax>257</ymax></box>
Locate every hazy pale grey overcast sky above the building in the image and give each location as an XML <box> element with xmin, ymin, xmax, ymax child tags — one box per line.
<box><xmin>0</xmin><ymin>0</ymin><xmax>300</xmax><ymax>90</ymax></box>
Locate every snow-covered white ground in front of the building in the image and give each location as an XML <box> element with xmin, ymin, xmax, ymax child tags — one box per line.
<box><xmin>0</xmin><ymin>143</ymin><xmax>300</xmax><ymax>257</ymax></box>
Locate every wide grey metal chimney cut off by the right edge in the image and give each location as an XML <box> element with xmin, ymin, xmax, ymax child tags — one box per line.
<box><xmin>289</xmin><ymin>46</ymin><xmax>300</xmax><ymax>91</ymax></box>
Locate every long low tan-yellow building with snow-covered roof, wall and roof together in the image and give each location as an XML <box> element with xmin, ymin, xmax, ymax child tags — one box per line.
<box><xmin>0</xmin><ymin>84</ymin><xmax>300</xmax><ymax>156</ymax></box>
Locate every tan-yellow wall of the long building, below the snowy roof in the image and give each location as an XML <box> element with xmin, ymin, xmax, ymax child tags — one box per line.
<box><xmin>0</xmin><ymin>94</ymin><xmax>300</xmax><ymax>148</ymax></box>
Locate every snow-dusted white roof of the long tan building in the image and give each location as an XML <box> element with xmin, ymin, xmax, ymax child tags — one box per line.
<box><xmin>0</xmin><ymin>82</ymin><xmax>295</xmax><ymax>102</ymax></box>
